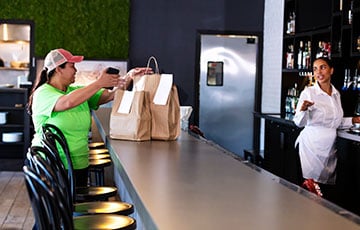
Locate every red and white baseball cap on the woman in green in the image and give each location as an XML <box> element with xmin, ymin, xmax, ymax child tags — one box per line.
<box><xmin>44</xmin><ymin>48</ymin><xmax>84</xmax><ymax>73</ymax></box>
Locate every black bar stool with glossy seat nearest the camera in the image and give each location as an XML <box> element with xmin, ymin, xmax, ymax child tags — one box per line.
<box><xmin>23</xmin><ymin>166</ymin><xmax>136</xmax><ymax>230</ymax></box>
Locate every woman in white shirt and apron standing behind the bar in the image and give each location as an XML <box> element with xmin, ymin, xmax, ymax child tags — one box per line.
<box><xmin>294</xmin><ymin>57</ymin><xmax>360</xmax><ymax>200</ymax></box>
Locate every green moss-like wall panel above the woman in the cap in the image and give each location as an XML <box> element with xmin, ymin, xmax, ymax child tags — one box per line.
<box><xmin>0</xmin><ymin>0</ymin><xmax>130</xmax><ymax>59</ymax></box>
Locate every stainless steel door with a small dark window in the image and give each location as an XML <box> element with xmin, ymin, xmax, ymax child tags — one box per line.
<box><xmin>199</xmin><ymin>35</ymin><xmax>258</xmax><ymax>156</ymax></box>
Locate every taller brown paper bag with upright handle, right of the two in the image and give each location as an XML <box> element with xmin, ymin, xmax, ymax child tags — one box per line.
<box><xmin>134</xmin><ymin>57</ymin><xmax>180</xmax><ymax>140</ymax></box>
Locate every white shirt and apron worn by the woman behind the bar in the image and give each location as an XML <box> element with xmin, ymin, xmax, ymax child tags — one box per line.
<box><xmin>293</xmin><ymin>83</ymin><xmax>352</xmax><ymax>184</ymax></box>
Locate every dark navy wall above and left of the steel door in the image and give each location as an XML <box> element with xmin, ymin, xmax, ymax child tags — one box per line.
<box><xmin>129</xmin><ymin>0</ymin><xmax>264</xmax><ymax>124</ymax></box>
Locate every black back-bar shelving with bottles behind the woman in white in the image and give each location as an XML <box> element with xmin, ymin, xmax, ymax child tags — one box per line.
<box><xmin>281</xmin><ymin>0</ymin><xmax>360</xmax><ymax>117</ymax></box>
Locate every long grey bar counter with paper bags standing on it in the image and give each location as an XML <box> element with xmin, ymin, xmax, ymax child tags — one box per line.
<box><xmin>93</xmin><ymin>108</ymin><xmax>360</xmax><ymax>230</ymax></box>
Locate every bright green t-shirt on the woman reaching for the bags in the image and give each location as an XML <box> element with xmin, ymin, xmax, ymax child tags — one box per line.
<box><xmin>32</xmin><ymin>84</ymin><xmax>104</xmax><ymax>169</ymax></box>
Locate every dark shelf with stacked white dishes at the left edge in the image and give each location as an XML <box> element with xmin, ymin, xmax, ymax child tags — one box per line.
<box><xmin>0</xmin><ymin>88</ymin><xmax>30</xmax><ymax>159</ymax></box>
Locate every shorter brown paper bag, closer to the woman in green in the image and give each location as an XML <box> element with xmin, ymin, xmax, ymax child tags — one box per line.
<box><xmin>110</xmin><ymin>89</ymin><xmax>151</xmax><ymax>141</ymax></box>
